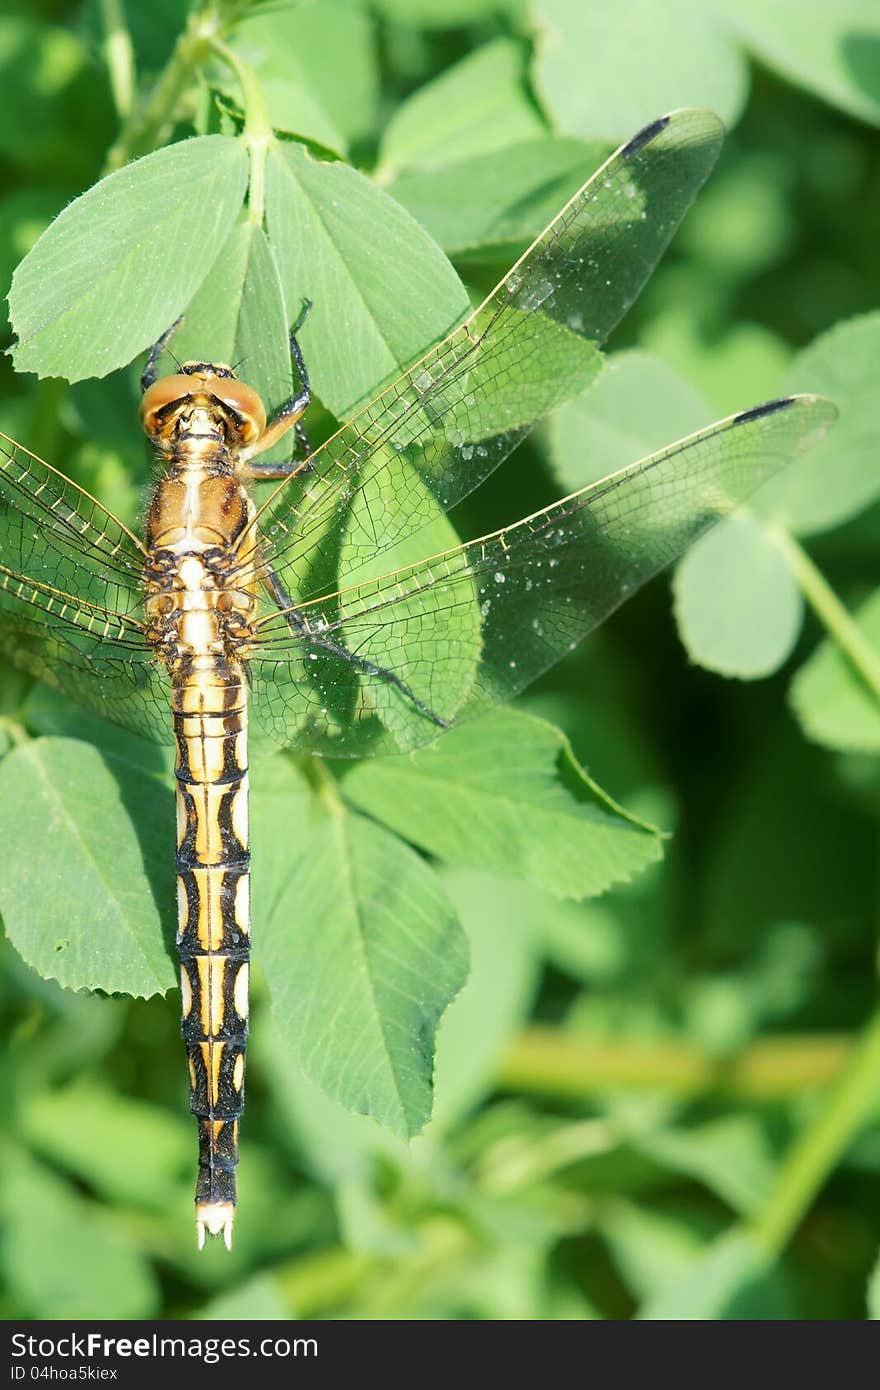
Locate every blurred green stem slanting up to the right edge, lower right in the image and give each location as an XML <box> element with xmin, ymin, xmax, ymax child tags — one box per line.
<box><xmin>752</xmin><ymin>1009</ymin><xmax>880</xmax><ymax>1258</ymax></box>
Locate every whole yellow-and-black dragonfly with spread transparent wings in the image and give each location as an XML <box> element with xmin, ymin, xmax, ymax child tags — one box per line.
<box><xmin>0</xmin><ymin>110</ymin><xmax>834</xmax><ymax>1248</ymax></box>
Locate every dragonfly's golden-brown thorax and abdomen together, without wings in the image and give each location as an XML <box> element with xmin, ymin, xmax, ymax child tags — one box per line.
<box><xmin>145</xmin><ymin>430</ymin><xmax>256</xmax><ymax>1248</ymax></box>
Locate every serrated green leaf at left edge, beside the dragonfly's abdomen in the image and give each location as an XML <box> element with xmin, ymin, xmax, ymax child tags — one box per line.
<box><xmin>0</xmin><ymin>738</ymin><xmax>177</xmax><ymax>995</ymax></box>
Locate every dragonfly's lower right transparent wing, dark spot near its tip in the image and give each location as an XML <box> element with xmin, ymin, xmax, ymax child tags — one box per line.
<box><xmin>243</xmin><ymin>396</ymin><xmax>836</xmax><ymax>755</ymax></box>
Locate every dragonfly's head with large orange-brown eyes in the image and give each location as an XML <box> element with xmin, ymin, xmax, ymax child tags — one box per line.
<box><xmin>140</xmin><ymin>361</ymin><xmax>266</xmax><ymax>452</ymax></box>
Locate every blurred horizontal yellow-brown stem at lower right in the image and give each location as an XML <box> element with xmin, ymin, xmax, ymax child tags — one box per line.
<box><xmin>498</xmin><ymin>1027</ymin><xmax>852</xmax><ymax>1101</ymax></box>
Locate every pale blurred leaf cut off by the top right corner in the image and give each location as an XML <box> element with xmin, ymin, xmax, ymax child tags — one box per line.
<box><xmin>722</xmin><ymin>0</ymin><xmax>880</xmax><ymax>125</ymax></box>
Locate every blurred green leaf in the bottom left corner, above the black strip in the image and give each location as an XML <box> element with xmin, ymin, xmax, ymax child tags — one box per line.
<box><xmin>0</xmin><ymin>1147</ymin><xmax>158</xmax><ymax>1319</ymax></box>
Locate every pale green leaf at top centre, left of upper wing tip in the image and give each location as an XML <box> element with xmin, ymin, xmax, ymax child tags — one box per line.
<box><xmin>380</xmin><ymin>39</ymin><xmax>542</xmax><ymax>175</ymax></box>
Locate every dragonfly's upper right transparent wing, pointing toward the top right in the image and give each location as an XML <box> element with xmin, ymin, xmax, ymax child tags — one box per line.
<box><xmin>256</xmin><ymin>110</ymin><xmax>723</xmax><ymax>599</ymax></box>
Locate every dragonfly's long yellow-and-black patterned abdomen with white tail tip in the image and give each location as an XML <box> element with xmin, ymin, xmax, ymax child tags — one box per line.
<box><xmin>171</xmin><ymin>655</ymin><xmax>250</xmax><ymax>1248</ymax></box>
